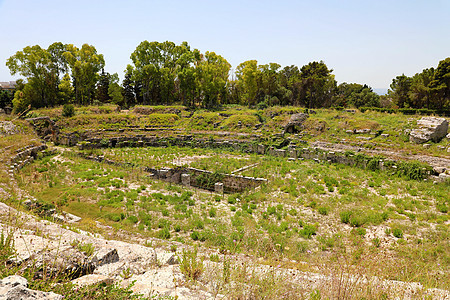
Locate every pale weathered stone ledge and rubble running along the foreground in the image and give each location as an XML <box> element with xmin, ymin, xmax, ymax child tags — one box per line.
<box><xmin>0</xmin><ymin>198</ymin><xmax>450</xmax><ymax>300</ymax></box>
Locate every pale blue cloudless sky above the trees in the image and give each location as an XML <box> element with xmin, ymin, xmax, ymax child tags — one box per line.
<box><xmin>0</xmin><ymin>0</ymin><xmax>450</xmax><ymax>88</ymax></box>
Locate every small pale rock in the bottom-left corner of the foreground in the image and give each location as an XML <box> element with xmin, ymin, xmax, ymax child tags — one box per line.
<box><xmin>0</xmin><ymin>275</ymin><xmax>63</xmax><ymax>300</ymax></box>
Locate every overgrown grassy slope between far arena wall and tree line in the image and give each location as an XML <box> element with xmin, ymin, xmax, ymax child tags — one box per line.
<box><xmin>33</xmin><ymin>106</ymin><xmax>450</xmax><ymax>158</ymax></box>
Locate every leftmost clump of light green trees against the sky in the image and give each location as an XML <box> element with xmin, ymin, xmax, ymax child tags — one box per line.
<box><xmin>6</xmin><ymin>42</ymin><xmax>105</xmax><ymax>111</ymax></box>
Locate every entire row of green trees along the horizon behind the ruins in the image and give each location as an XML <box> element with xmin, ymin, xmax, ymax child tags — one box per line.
<box><xmin>6</xmin><ymin>41</ymin><xmax>450</xmax><ymax>111</ymax></box>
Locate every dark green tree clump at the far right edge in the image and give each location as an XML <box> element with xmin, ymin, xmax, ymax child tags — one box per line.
<box><xmin>388</xmin><ymin>57</ymin><xmax>450</xmax><ymax>110</ymax></box>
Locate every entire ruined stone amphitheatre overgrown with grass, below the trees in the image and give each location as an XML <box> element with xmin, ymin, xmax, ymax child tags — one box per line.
<box><xmin>0</xmin><ymin>105</ymin><xmax>450</xmax><ymax>299</ymax></box>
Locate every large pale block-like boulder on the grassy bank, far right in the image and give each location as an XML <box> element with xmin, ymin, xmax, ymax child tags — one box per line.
<box><xmin>409</xmin><ymin>117</ymin><xmax>448</xmax><ymax>144</ymax></box>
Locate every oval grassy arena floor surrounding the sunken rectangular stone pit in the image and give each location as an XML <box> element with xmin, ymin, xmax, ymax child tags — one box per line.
<box><xmin>12</xmin><ymin>148</ymin><xmax>450</xmax><ymax>288</ymax></box>
